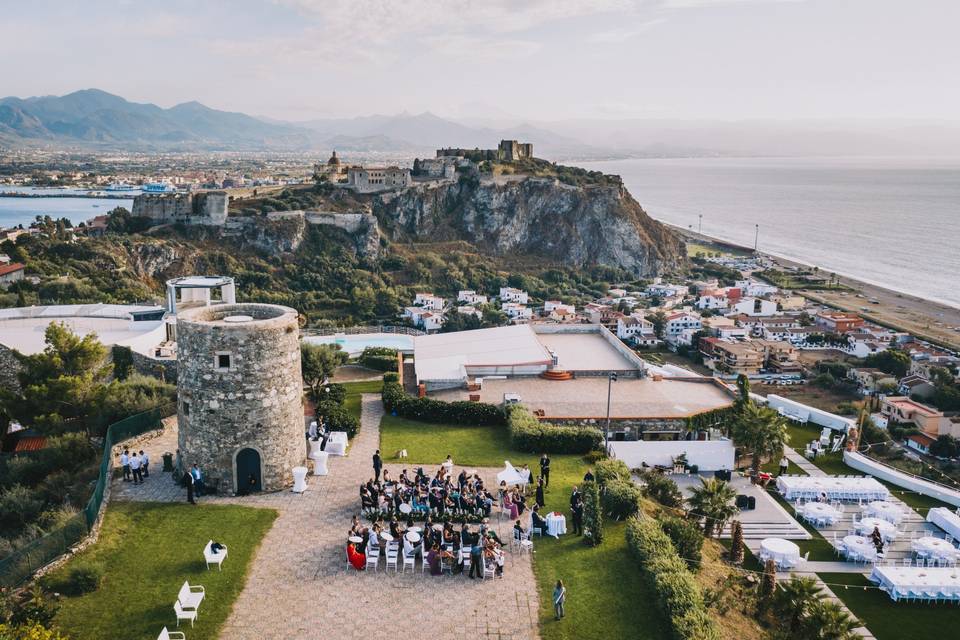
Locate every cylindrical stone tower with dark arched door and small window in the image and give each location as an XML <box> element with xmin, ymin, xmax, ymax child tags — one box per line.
<box><xmin>177</xmin><ymin>304</ymin><xmax>307</xmax><ymax>493</ymax></box>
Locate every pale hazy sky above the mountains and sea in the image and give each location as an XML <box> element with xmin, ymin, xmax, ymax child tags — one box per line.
<box><xmin>0</xmin><ymin>0</ymin><xmax>960</xmax><ymax>120</ymax></box>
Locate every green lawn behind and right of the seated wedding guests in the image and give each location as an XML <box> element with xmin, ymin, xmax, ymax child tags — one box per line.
<box><xmin>380</xmin><ymin>416</ymin><xmax>668</xmax><ymax>640</ymax></box>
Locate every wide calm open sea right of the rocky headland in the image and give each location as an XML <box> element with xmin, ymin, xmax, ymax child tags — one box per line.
<box><xmin>580</xmin><ymin>158</ymin><xmax>960</xmax><ymax>306</ymax></box>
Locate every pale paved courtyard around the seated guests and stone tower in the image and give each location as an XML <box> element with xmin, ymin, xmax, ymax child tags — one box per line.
<box><xmin>111</xmin><ymin>394</ymin><xmax>539</xmax><ymax>640</ymax></box>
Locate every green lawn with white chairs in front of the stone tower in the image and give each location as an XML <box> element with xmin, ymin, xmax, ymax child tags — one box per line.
<box><xmin>52</xmin><ymin>502</ymin><xmax>277</xmax><ymax>640</ymax></box>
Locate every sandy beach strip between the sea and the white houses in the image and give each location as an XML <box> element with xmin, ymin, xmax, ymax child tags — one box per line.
<box><xmin>672</xmin><ymin>220</ymin><xmax>960</xmax><ymax>350</ymax></box>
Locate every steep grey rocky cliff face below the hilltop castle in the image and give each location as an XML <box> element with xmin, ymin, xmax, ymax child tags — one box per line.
<box><xmin>373</xmin><ymin>178</ymin><xmax>686</xmax><ymax>276</ymax></box>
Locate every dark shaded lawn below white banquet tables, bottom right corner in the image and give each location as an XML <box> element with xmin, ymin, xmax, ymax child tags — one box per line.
<box><xmin>819</xmin><ymin>573</ymin><xmax>960</xmax><ymax>640</ymax></box>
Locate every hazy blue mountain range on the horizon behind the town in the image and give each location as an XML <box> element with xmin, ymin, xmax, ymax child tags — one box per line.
<box><xmin>0</xmin><ymin>89</ymin><xmax>596</xmax><ymax>156</ymax></box>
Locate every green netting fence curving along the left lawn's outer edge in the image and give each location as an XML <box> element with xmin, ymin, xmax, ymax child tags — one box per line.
<box><xmin>0</xmin><ymin>404</ymin><xmax>176</xmax><ymax>588</ymax></box>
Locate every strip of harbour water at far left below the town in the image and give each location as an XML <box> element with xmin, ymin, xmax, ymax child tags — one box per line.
<box><xmin>0</xmin><ymin>185</ymin><xmax>138</xmax><ymax>229</ymax></box>
